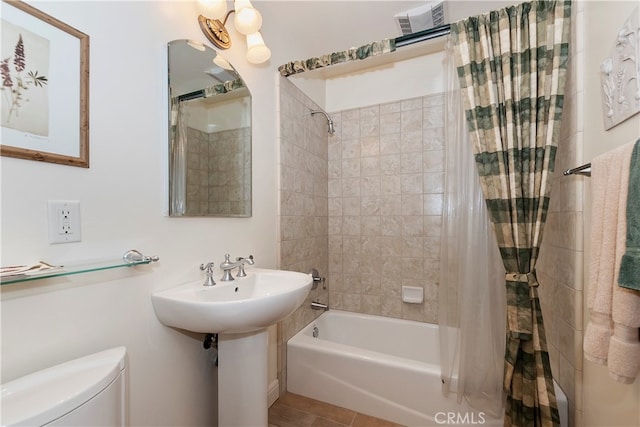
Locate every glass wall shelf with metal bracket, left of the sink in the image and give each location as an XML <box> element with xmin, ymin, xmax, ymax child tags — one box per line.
<box><xmin>0</xmin><ymin>250</ymin><xmax>159</xmax><ymax>285</ymax></box>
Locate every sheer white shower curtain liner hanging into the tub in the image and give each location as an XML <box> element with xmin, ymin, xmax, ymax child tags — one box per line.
<box><xmin>438</xmin><ymin>41</ymin><xmax>506</xmax><ymax>418</ymax></box>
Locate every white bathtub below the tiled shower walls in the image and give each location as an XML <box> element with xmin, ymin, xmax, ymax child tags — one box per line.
<box><xmin>287</xmin><ymin>310</ymin><xmax>568</xmax><ymax>426</ymax></box>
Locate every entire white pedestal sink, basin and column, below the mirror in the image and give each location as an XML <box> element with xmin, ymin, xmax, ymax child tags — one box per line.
<box><xmin>151</xmin><ymin>268</ymin><xmax>313</xmax><ymax>427</ymax></box>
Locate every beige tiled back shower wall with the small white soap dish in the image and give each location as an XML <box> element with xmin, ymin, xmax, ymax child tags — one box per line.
<box><xmin>328</xmin><ymin>94</ymin><xmax>444</xmax><ymax>323</ymax></box>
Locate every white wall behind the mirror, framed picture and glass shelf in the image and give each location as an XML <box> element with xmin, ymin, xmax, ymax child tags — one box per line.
<box><xmin>0</xmin><ymin>1</ymin><xmax>277</xmax><ymax>426</ymax></box>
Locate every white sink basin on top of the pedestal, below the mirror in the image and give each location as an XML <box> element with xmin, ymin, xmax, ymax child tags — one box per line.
<box><xmin>151</xmin><ymin>268</ymin><xmax>313</xmax><ymax>334</ymax></box>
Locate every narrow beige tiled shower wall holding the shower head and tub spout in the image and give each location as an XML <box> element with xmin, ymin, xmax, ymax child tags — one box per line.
<box><xmin>278</xmin><ymin>78</ymin><xmax>330</xmax><ymax>394</ymax></box>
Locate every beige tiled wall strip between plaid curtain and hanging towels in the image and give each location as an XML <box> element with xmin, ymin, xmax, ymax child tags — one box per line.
<box><xmin>537</xmin><ymin>2</ymin><xmax>588</xmax><ymax>427</ymax></box>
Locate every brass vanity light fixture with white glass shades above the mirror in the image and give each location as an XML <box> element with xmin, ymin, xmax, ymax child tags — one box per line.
<box><xmin>198</xmin><ymin>0</ymin><xmax>271</xmax><ymax>64</ymax></box>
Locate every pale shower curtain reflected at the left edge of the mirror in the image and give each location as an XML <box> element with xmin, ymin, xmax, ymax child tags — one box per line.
<box><xmin>169</xmin><ymin>100</ymin><xmax>187</xmax><ymax>215</ymax></box>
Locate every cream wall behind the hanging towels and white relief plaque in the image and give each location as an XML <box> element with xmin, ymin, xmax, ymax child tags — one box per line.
<box><xmin>578</xmin><ymin>1</ymin><xmax>640</xmax><ymax>427</ymax></box>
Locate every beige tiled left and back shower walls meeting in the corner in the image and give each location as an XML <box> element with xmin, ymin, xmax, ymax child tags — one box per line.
<box><xmin>278</xmin><ymin>78</ymin><xmax>444</xmax><ymax>391</ymax></box>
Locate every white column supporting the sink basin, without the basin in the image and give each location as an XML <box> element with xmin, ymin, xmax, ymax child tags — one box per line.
<box><xmin>218</xmin><ymin>329</ymin><xmax>269</xmax><ymax>427</ymax></box>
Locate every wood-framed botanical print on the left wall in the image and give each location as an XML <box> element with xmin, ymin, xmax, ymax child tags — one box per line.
<box><xmin>0</xmin><ymin>0</ymin><xmax>89</xmax><ymax>168</ymax></box>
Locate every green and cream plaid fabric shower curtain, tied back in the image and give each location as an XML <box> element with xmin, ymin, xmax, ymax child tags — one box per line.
<box><xmin>451</xmin><ymin>0</ymin><xmax>571</xmax><ymax>426</ymax></box>
